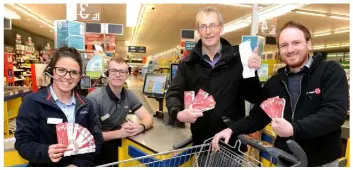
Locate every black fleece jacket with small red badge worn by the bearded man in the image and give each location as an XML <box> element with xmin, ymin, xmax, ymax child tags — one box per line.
<box><xmin>231</xmin><ymin>53</ymin><xmax>348</xmax><ymax>166</ymax></box>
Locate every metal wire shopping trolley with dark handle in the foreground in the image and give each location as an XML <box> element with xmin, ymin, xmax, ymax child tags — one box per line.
<box><xmin>96</xmin><ymin>135</ymin><xmax>307</xmax><ymax>167</ymax></box>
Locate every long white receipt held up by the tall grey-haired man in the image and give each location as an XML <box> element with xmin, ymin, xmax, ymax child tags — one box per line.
<box><xmin>239</xmin><ymin>41</ymin><xmax>255</xmax><ymax>79</ymax></box>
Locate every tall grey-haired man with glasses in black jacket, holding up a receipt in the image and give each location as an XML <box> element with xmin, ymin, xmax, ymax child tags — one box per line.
<box><xmin>166</xmin><ymin>8</ymin><xmax>263</xmax><ymax>145</ymax></box>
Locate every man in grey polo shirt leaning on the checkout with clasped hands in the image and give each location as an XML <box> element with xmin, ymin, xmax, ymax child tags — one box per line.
<box><xmin>87</xmin><ymin>57</ymin><xmax>153</xmax><ymax>165</ymax></box>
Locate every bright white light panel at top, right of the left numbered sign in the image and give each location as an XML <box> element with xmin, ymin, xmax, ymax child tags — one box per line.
<box><xmin>126</xmin><ymin>2</ymin><xmax>141</xmax><ymax>27</ymax></box>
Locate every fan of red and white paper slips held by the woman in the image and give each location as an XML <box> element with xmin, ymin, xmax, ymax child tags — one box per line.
<box><xmin>56</xmin><ymin>123</ymin><xmax>96</xmax><ymax>156</ymax></box>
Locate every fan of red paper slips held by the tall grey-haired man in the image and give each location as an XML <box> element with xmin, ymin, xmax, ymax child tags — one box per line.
<box><xmin>184</xmin><ymin>89</ymin><xmax>216</xmax><ymax>112</ymax></box>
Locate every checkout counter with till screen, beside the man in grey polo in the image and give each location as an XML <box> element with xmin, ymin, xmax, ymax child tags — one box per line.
<box><xmin>115</xmin><ymin>73</ymin><xmax>192</xmax><ymax>166</ymax></box>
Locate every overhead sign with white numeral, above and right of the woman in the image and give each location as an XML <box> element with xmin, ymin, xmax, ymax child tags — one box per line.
<box><xmin>77</xmin><ymin>3</ymin><xmax>102</xmax><ymax>22</ymax></box>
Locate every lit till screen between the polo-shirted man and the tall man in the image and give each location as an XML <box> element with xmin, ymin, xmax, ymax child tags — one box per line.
<box><xmin>142</xmin><ymin>73</ymin><xmax>168</xmax><ymax>98</ymax></box>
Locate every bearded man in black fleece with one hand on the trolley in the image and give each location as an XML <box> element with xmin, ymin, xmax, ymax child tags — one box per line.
<box><xmin>212</xmin><ymin>21</ymin><xmax>348</xmax><ymax>166</ymax></box>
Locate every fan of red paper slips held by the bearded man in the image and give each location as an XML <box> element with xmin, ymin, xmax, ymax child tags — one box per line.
<box><xmin>260</xmin><ymin>96</ymin><xmax>286</xmax><ymax>118</ymax></box>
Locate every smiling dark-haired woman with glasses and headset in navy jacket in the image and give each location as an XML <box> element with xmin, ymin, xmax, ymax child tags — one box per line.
<box><xmin>15</xmin><ymin>47</ymin><xmax>103</xmax><ymax>166</ymax></box>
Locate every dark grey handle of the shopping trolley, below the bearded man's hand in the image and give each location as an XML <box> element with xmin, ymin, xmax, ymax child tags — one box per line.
<box><xmin>238</xmin><ymin>135</ymin><xmax>307</xmax><ymax>167</ymax></box>
